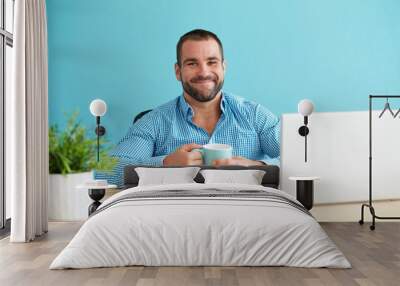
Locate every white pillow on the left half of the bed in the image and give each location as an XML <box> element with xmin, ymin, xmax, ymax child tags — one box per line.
<box><xmin>135</xmin><ymin>167</ymin><xmax>200</xmax><ymax>186</ymax></box>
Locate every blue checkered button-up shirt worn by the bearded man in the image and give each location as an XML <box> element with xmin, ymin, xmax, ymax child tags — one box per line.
<box><xmin>95</xmin><ymin>92</ymin><xmax>280</xmax><ymax>187</ymax></box>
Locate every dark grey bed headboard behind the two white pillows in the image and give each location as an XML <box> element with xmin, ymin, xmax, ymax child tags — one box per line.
<box><xmin>123</xmin><ymin>165</ymin><xmax>279</xmax><ymax>189</ymax></box>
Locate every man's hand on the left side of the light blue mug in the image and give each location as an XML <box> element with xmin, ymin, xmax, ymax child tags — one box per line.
<box><xmin>163</xmin><ymin>143</ymin><xmax>203</xmax><ymax>166</ymax></box>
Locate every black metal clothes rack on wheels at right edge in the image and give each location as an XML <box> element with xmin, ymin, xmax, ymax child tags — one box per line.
<box><xmin>358</xmin><ymin>95</ymin><xmax>400</xmax><ymax>230</ymax></box>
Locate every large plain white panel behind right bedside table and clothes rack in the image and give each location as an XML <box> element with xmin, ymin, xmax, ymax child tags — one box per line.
<box><xmin>281</xmin><ymin>110</ymin><xmax>400</xmax><ymax>204</ymax></box>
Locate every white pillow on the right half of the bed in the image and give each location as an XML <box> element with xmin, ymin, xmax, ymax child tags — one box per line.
<box><xmin>200</xmin><ymin>169</ymin><xmax>265</xmax><ymax>185</ymax></box>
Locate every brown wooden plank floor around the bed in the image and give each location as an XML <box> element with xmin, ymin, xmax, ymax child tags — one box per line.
<box><xmin>0</xmin><ymin>222</ymin><xmax>400</xmax><ymax>286</ymax></box>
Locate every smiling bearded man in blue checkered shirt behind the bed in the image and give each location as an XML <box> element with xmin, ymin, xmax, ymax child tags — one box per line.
<box><xmin>96</xmin><ymin>30</ymin><xmax>280</xmax><ymax>185</ymax></box>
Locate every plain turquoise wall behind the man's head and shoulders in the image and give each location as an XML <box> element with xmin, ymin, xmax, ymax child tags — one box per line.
<box><xmin>47</xmin><ymin>0</ymin><xmax>400</xmax><ymax>143</ymax></box>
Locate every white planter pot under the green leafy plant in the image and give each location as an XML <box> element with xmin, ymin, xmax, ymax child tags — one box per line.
<box><xmin>48</xmin><ymin>172</ymin><xmax>93</xmax><ymax>221</ymax></box>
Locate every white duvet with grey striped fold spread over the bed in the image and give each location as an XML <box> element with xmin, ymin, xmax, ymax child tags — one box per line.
<box><xmin>50</xmin><ymin>183</ymin><xmax>351</xmax><ymax>269</ymax></box>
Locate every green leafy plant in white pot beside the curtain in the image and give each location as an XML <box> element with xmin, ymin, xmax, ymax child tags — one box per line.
<box><xmin>48</xmin><ymin>112</ymin><xmax>117</xmax><ymax>220</ymax></box>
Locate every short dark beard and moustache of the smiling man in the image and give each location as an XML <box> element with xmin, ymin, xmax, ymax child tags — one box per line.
<box><xmin>181</xmin><ymin>75</ymin><xmax>224</xmax><ymax>102</ymax></box>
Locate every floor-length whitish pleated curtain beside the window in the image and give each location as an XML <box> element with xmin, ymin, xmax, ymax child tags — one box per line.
<box><xmin>6</xmin><ymin>0</ymin><xmax>49</xmax><ymax>242</ymax></box>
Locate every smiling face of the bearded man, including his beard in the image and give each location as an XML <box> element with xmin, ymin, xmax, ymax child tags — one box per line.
<box><xmin>175</xmin><ymin>39</ymin><xmax>225</xmax><ymax>102</ymax></box>
